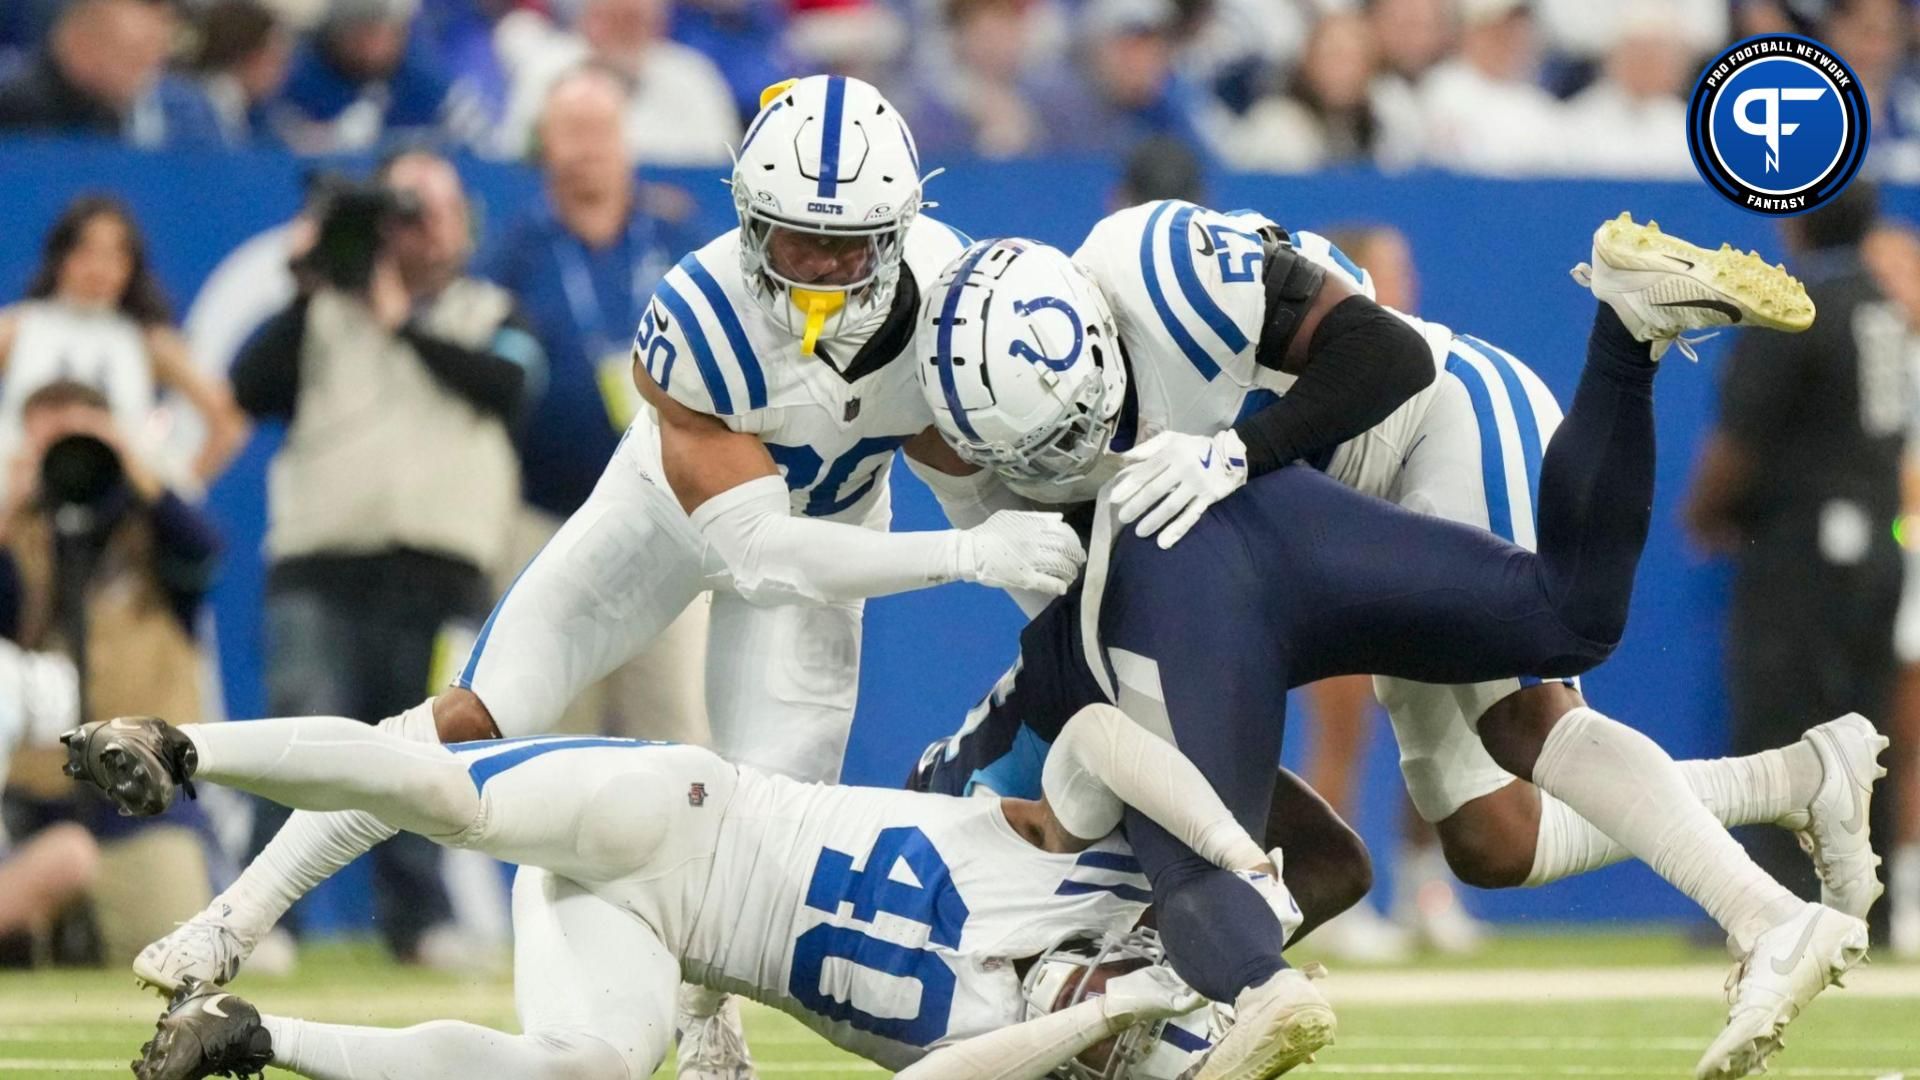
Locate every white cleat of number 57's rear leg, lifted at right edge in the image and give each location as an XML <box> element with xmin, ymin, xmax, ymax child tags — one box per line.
<box><xmin>1780</xmin><ymin>713</ymin><xmax>1887</xmax><ymax>919</ymax></box>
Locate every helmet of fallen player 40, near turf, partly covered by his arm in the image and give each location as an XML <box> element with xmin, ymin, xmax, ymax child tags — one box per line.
<box><xmin>1021</xmin><ymin>928</ymin><xmax>1233</xmax><ymax>1080</ymax></box>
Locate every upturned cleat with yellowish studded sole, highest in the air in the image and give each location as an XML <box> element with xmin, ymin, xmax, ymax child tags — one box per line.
<box><xmin>1572</xmin><ymin>213</ymin><xmax>1812</xmax><ymax>359</ymax></box>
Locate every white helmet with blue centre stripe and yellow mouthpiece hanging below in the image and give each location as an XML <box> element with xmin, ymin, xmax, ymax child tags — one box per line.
<box><xmin>733</xmin><ymin>75</ymin><xmax>922</xmax><ymax>354</ymax></box>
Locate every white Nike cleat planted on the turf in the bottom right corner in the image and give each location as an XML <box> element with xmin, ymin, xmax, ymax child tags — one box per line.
<box><xmin>1693</xmin><ymin>903</ymin><xmax>1866</xmax><ymax>1080</ymax></box>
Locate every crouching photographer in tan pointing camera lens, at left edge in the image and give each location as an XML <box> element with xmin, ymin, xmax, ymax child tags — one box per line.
<box><xmin>0</xmin><ymin>380</ymin><xmax>219</xmax><ymax>963</ymax></box>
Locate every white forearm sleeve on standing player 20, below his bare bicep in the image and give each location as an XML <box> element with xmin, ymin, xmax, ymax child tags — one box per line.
<box><xmin>691</xmin><ymin>477</ymin><xmax>968</xmax><ymax>605</ymax></box>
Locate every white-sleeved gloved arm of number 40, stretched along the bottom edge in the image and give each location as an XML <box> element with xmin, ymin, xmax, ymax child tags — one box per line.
<box><xmin>899</xmin><ymin>967</ymin><xmax>1202</xmax><ymax>1080</ymax></box>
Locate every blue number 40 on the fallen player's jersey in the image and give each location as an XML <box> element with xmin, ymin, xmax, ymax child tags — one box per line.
<box><xmin>787</xmin><ymin>826</ymin><xmax>968</xmax><ymax>1045</ymax></box>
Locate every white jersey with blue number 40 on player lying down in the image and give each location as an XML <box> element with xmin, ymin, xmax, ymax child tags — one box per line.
<box><xmin>684</xmin><ymin>769</ymin><xmax>1148</xmax><ymax>1070</ymax></box>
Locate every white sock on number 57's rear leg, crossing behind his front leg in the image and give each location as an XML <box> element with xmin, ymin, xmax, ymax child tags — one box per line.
<box><xmin>1526</xmin><ymin>742</ymin><xmax>1822</xmax><ymax>888</ymax></box>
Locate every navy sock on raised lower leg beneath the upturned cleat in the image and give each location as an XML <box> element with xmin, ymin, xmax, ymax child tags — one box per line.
<box><xmin>1540</xmin><ymin>304</ymin><xmax>1659</xmax><ymax>644</ymax></box>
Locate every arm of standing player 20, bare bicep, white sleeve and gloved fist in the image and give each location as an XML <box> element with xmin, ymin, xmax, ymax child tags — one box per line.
<box><xmin>634</xmin><ymin>363</ymin><xmax>1085</xmax><ymax>603</ymax></box>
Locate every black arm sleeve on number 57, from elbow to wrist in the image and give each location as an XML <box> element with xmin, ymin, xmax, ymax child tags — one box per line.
<box><xmin>1233</xmin><ymin>296</ymin><xmax>1434</xmax><ymax>477</ymax></box>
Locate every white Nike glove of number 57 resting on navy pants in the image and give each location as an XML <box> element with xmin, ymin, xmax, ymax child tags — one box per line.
<box><xmin>1112</xmin><ymin>429</ymin><xmax>1246</xmax><ymax>548</ymax></box>
